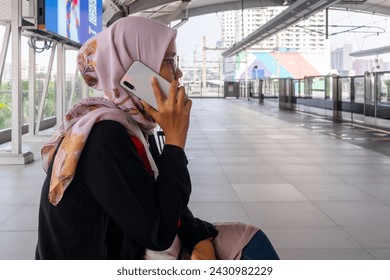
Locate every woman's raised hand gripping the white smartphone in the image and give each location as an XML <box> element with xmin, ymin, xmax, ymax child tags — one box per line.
<box><xmin>141</xmin><ymin>77</ymin><xmax>192</xmax><ymax>149</ymax></box>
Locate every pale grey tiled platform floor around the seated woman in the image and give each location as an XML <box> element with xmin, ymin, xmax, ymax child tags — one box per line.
<box><xmin>0</xmin><ymin>99</ymin><xmax>390</xmax><ymax>260</ymax></box>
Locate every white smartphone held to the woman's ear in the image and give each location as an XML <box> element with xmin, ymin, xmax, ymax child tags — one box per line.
<box><xmin>120</xmin><ymin>60</ymin><xmax>170</xmax><ymax>110</ymax></box>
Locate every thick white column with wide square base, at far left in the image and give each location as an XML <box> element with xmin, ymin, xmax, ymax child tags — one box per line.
<box><xmin>0</xmin><ymin>0</ymin><xmax>34</xmax><ymax>164</ymax></box>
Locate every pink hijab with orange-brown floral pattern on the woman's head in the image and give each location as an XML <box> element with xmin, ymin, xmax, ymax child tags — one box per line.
<box><xmin>41</xmin><ymin>17</ymin><xmax>176</xmax><ymax>206</ymax></box>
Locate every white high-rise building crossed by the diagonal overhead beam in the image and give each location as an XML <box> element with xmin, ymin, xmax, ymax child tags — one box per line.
<box><xmin>222</xmin><ymin>7</ymin><xmax>329</xmax><ymax>52</ymax></box>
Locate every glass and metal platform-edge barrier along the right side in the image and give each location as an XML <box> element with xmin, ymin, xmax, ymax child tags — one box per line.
<box><xmin>279</xmin><ymin>72</ymin><xmax>390</xmax><ymax>128</ymax></box>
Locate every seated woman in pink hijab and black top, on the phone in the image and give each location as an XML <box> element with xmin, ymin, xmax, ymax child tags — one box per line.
<box><xmin>36</xmin><ymin>17</ymin><xmax>278</xmax><ymax>259</ymax></box>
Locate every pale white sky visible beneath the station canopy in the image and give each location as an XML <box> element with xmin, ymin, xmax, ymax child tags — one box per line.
<box><xmin>0</xmin><ymin>10</ymin><xmax>390</xmax><ymax>73</ymax></box>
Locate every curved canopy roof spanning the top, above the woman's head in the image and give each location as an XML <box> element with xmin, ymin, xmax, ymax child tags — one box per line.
<box><xmin>99</xmin><ymin>0</ymin><xmax>390</xmax><ymax>26</ymax></box>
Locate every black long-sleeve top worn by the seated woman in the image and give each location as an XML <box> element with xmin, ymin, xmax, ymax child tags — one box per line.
<box><xmin>36</xmin><ymin>121</ymin><xmax>216</xmax><ymax>259</ymax></box>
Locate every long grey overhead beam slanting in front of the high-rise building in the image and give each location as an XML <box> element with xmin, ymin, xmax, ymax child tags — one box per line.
<box><xmin>222</xmin><ymin>0</ymin><xmax>339</xmax><ymax>57</ymax></box>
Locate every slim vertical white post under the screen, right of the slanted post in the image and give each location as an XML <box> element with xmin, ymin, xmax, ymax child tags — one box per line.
<box><xmin>56</xmin><ymin>43</ymin><xmax>65</xmax><ymax>126</ymax></box>
